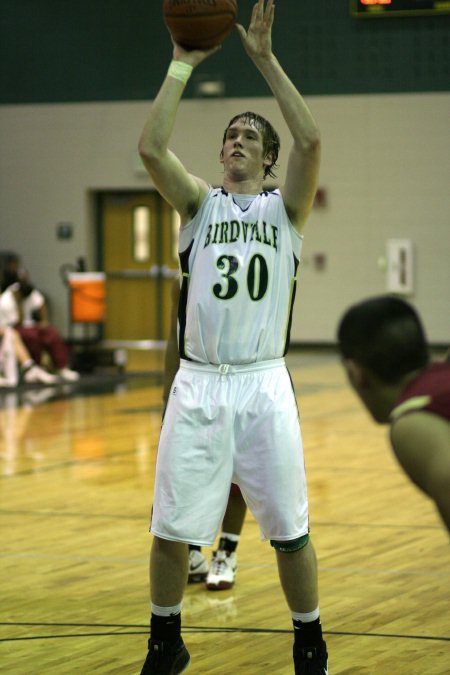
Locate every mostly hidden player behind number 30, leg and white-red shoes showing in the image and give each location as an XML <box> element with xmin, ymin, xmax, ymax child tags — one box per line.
<box><xmin>163</xmin><ymin>277</ymin><xmax>247</xmax><ymax>591</ymax></box>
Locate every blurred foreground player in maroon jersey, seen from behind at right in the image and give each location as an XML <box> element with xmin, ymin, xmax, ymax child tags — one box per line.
<box><xmin>338</xmin><ymin>296</ymin><xmax>450</xmax><ymax>530</ymax></box>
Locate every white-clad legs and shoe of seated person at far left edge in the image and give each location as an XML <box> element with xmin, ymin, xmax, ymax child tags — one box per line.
<box><xmin>0</xmin><ymin>326</ymin><xmax>58</xmax><ymax>387</ymax></box>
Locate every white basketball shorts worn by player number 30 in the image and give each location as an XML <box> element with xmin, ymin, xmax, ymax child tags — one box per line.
<box><xmin>150</xmin><ymin>359</ymin><xmax>308</xmax><ymax>546</ymax></box>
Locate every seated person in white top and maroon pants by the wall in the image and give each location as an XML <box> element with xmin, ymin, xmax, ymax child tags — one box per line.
<box><xmin>0</xmin><ymin>278</ymin><xmax>80</xmax><ymax>382</ymax></box>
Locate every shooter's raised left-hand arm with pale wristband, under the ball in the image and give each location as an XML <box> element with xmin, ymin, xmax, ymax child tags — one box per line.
<box><xmin>139</xmin><ymin>44</ymin><xmax>219</xmax><ymax>222</ymax></box>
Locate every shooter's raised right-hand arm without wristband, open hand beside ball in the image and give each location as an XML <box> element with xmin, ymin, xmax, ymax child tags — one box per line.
<box><xmin>237</xmin><ymin>0</ymin><xmax>320</xmax><ymax>230</ymax></box>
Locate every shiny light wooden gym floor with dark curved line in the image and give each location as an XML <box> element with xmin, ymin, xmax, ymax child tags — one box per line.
<box><xmin>0</xmin><ymin>352</ymin><xmax>450</xmax><ymax>675</ymax></box>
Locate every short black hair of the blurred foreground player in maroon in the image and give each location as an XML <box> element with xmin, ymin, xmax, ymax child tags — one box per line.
<box><xmin>337</xmin><ymin>295</ymin><xmax>430</xmax><ymax>383</ymax></box>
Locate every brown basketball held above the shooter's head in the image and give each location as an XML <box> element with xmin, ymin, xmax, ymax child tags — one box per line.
<box><xmin>163</xmin><ymin>0</ymin><xmax>237</xmax><ymax>49</ymax></box>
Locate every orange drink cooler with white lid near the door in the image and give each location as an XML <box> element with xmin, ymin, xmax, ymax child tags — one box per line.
<box><xmin>69</xmin><ymin>272</ymin><xmax>105</xmax><ymax>323</ymax></box>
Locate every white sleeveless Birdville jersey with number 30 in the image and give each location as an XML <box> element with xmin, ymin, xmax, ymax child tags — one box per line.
<box><xmin>178</xmin><ymin>188</ymin><xmax>303</xmax><ymax>364</ymax></box>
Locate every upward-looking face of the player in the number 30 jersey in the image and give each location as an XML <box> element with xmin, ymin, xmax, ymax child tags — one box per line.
<box><xmin>221</xmin><ymin>120</ymin><xmax>270</xmax><ymax>178</ymax></box>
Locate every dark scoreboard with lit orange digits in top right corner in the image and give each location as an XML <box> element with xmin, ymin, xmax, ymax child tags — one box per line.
<box><xmin>350</xmin><ymin>0</ymin><xmax>450</xmax><ymax>18</ymax></box>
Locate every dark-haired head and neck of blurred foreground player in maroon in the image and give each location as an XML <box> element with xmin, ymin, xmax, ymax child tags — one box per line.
<box><xmin>337</xmin><ymin>295</ymin><xmax>430</xmax><ymax>422</ymax></box>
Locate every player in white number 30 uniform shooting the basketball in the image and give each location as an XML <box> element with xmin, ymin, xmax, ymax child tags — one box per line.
<box><xmin>139</xmin><ymin>0</ymin><xmax>328</xmax><ymax>675</ymax></box>
